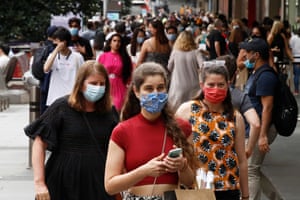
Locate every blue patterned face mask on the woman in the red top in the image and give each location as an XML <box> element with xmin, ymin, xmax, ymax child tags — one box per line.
<box><xmin>140</xmin><ymin>92</ymin><xmax>168</xmax><ymax>113</ymax></box>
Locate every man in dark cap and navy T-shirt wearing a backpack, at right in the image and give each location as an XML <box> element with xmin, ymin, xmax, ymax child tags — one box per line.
<box><xmin>240</xmin><ymin>38</ymin><xmax>283</xmax><ymax>200</ymax></box>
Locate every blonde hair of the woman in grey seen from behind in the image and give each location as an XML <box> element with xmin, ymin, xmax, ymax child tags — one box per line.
<box><xmin>173</xmin><ymin>31</ymin><xmax>197</xmax><ymax>51</ymax></box>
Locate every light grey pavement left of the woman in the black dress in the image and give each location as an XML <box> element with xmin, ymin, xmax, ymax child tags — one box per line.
<box><xmin>0</xmin><ymin>104</ymin><xmax>34</xmax><ymax>200</ymax></box>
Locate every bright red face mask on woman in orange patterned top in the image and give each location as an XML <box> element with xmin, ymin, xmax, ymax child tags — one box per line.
<box><xmin>203</xmin><ymin>87</ymin><xmax>227</xmax><ymax>103</ymax></box>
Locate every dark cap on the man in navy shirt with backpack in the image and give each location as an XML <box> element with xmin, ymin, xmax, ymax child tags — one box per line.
<box><xmin>240</xmin><ymin>38</ymin><xmax>269</xmax><ymax>54</ymax></box>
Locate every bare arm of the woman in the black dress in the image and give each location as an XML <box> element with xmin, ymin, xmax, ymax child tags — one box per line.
<box><xmin>32</xmin><ymin>136</ymin><xmax>48</xmax><ymax>194</ymax></box>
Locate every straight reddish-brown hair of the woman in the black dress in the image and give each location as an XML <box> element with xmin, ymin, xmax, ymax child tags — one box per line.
<box><xmin>68</xmin><ymin>60</ymin><xmax>112</xmax><ymax>113</ymax></box>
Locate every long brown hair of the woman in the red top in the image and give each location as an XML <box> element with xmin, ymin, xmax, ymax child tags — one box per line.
<box><xmin>121</xmin><ymin>62</ymin><xmax>197</xmax><ymax>167</ymax></box>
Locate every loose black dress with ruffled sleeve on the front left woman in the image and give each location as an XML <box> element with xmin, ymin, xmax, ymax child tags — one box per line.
<box><xmin>24</xmin><ymin>97</ymin><xmax>118</xmax><ymax>200</ymax></box>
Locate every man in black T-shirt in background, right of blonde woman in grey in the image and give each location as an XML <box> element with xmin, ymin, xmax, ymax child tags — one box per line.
<box><xmin>207</xmin><ymin>19</ymin><xmax>226</xmax><ymax>59</ymax></box>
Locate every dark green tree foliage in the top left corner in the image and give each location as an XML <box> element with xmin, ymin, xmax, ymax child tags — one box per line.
<box><xmin>0</xmin><ymin>0</ymin><xmax>100</xmax><ymax>42</ymax></box>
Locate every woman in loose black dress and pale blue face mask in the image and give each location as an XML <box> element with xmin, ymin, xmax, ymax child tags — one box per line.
<box><xmin>24</xmin><ymin>61</ymin><xmax>118</xmax><ymax>200</ymax></box>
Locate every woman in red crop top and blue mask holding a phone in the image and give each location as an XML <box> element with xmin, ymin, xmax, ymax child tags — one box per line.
<box><xmin>105</xmin><ymin>62</ymin><xmax>194</xmax><ymax>200</ymax></box>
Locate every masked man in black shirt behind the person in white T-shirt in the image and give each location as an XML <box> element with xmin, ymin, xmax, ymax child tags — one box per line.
<box><xmin>69</xmin><ymin>17</ymin><xmax>94</xmax><ymax>60</ymax></box>
